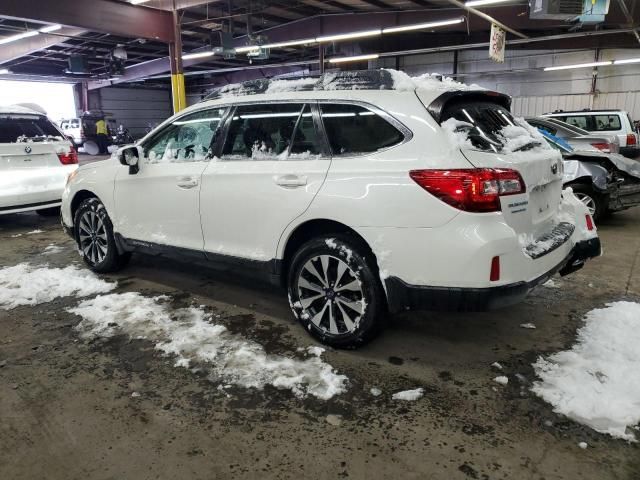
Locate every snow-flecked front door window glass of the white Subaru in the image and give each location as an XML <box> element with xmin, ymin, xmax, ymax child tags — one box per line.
<box><xmin>145</xmin><ymin>108</ymin><xmax>226</xmax><ymax>163</ymax></box>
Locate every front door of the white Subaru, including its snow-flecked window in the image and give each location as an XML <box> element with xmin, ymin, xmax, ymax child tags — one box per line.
<box><xmin>115</xmin><ymin>108</ymin><xmax>225</xmax><ymax>251</ymax></box>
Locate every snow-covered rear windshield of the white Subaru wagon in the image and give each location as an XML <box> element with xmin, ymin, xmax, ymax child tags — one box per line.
<box><xmin>442</xmin><ymin>101</ymin><xmax>546</xmax><ymax>153</ymax></box>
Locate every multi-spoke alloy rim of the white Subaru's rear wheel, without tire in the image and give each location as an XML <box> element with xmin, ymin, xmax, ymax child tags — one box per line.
<box><xmin>297</xmin><ymin>255</ymin><xmax>366</xmax><ymax>335</ymax></box>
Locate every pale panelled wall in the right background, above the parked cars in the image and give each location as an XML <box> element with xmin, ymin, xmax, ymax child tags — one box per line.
<box><xmin>376</xmin><ymin>49</ymin><xmax>640</xmax><ymax>119</ymax></box>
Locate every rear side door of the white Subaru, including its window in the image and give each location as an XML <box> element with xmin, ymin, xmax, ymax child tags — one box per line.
<box><xmin>200</xmin><ymin>103</ymin><xmax>331</xmax><ymax>261</ymax></box>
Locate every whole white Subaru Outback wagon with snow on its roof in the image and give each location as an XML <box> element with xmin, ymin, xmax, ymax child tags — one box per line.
<box><xmin>62</xmin><ymin>70</ymin><xmax>600</xmax><ymax>347</ymax></box>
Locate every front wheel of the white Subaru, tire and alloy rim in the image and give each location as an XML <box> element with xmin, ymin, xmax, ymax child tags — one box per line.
<box><xmin>73</xmin><ymin>198</ymin><xmax>131</xmax><ymax>273</ymax></box>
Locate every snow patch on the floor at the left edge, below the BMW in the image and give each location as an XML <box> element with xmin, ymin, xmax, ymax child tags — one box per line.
<box><xmin>0</xmin><ymin>263</ymin><xmax>116</xmax><ymax>310</ymax></box>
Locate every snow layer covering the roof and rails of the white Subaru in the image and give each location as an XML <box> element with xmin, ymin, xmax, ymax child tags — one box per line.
<box><xmin>205</xmin><ymin>69</ymin><xmax>484</xmax><ymax>100</ymax></box>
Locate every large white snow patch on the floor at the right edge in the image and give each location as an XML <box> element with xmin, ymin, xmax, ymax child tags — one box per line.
<box><xmin>532</xmin><ymin>302</ymin><xmax>640</xmax><ymax>441</ymax></box>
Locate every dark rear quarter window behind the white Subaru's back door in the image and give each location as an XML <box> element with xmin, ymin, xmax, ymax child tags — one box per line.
<box><xmin>320</xmin><ymin>104</ymin><xmax>404</xmax><ymax>155</ymax></box>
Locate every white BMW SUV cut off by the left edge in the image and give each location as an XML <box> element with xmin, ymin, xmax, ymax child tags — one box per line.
<box><xmin>0</xmin><ymin>105</ymin><xmax>78</xmax><ymax>215</ymax></box>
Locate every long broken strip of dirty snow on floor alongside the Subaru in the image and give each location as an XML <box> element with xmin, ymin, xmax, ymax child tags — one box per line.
<box><xmin>69</xmin><ymin>292</ymin><xmax>347</xmax><ymax>400</ymax></box>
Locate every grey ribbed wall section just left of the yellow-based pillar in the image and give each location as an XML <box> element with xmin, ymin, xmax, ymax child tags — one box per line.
<box><xmin>89</xmin><ymin>87</ymin><xmax>173</xmax><ymax>138</ymax></box>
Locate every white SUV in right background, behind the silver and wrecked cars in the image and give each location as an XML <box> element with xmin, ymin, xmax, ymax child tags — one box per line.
<box><xmin>543</xmin><ymin>110</ymin><xmax>640</xmax><ymax>158</ymax></box>
